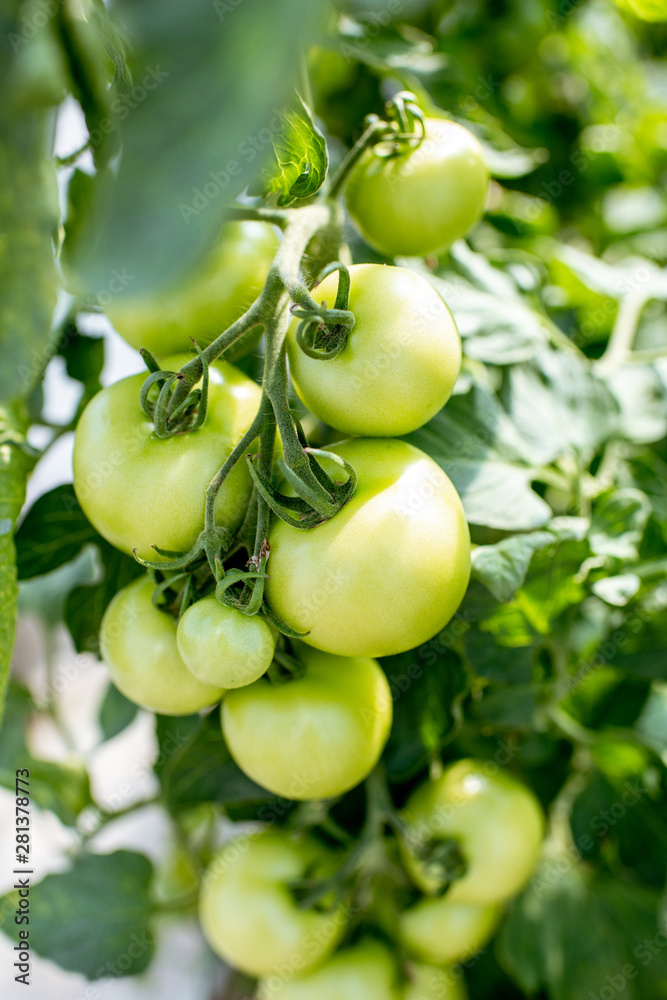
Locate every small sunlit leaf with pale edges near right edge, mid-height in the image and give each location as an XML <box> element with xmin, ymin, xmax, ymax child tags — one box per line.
<box><xmin>588</xmin><ymin>489</ymin><xmax>651</xmax><ymax>562</ymax></box>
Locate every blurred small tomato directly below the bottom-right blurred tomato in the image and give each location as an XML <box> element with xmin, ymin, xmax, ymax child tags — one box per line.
<box><xmin>400</xmin><ymin>895</ymin><xmax>501</xmax><ymax>965</ymax></box>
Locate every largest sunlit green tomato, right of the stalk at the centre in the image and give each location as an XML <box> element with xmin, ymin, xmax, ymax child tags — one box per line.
<box><xmin>266</xmin><ymin>440</ymin><xmax>470</xmax><ymax>656</ymax></box>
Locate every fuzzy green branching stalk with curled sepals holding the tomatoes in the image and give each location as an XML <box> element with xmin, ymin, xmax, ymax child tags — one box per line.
<box><xmin>135</xmin><ymin>92</ymin><xmax>424</xmax><ymax>637</ymax></box>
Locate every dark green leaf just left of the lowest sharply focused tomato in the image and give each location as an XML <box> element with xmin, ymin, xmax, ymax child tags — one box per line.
<box><xmin>155</xmin><ymin>711</ymin><xmax>275</xmax><ymax>812</ymax></box>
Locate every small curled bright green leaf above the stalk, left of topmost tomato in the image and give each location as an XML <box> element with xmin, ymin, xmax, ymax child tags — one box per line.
<box><xmin>262</xmin><ymin>98</ymin><xmax>329</xmax><ymax>205</ymax></box>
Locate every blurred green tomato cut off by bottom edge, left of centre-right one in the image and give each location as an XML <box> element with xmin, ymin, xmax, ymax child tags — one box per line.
<box><xmin>257</xmin><ymin>939</ymin><xmax>401</xmax><ymax>1000</ymax></box>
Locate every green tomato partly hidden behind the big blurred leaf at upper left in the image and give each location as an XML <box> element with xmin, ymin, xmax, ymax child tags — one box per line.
<box><xmin>107</xmin><ymin>222</ymin><xmax>278</xmax><ymax>361</ymax></box>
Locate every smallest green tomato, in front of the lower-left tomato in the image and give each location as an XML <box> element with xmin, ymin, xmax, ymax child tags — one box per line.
<box><xmin>176</xmin><ymin>597</ymin><xmax>276</xmax><ymax>688</ymax></box>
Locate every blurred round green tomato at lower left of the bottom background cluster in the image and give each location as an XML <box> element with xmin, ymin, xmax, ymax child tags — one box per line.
<box><xmin>199</xmin><ymin>830</ymin><xmax>347</xmax><ymax>978</ymax></box>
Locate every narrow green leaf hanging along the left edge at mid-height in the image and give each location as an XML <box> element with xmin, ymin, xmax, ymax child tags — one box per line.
<box><xmin>0</xmin><ymin>407</ymin><xmax>34</xmax><ymax>722</ymax></box>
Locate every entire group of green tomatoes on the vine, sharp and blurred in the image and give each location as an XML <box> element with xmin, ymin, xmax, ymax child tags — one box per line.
<box><xmin>69</xmin><ymin>109</ymin><xmax>542</xmax><ymax>1000</ymax></box>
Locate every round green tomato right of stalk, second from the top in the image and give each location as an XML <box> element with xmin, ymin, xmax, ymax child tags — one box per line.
<box><xmin>288</xmin><ymin>264</ymin><xmax>461</xmax><ymax>437</ymax></box>
